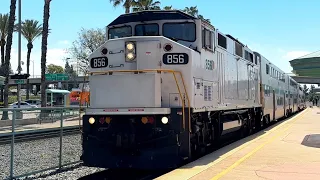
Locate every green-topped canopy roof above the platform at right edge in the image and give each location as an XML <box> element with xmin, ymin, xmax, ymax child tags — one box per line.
<box><xmin>289</xmin><ymin>51</ymin><xmax>320</xmax><ymax>78</ymax></box>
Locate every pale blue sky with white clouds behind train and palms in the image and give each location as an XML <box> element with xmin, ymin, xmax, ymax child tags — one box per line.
<box><xmin>0</xmin><ymin>0</ymin><xmax>320</xmax><ymax>79</ymax></box>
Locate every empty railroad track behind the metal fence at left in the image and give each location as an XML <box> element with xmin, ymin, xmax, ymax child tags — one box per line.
<box><xmin>0</xmin><ymin>126</ymin><xmax>80</xmax><ymax>145</ymax></box>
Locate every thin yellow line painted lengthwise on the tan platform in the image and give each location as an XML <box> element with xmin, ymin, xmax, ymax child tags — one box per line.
<box><xmin>210</xmin><ymin>109</ymin><xmax>309</xmax><ymax>180</ymax></box>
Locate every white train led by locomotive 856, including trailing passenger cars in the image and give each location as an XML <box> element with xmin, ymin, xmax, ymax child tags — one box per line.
<box><xmin>81</xmin><ymin>11</ymin><xmax>305</xmax><ymax>169</ymax></box>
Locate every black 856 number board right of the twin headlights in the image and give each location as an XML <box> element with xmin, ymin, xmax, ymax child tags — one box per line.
<box><xmin>162</xmin><ymin>53</ymin><xmax>189</xmax><ymax>65</ymax></box>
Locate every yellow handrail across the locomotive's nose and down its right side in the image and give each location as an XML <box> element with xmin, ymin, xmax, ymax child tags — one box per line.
<box><xmin>90</xmin><ymin>69</ymin><xmax>191</xmax><ymax>132</ymax></box>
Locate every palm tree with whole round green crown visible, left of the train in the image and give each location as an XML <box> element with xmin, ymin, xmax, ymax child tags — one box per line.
<box><xmin>21</xmin><ymin>19</ymin><xmax>42</xmax><ymax>99</ymax></box>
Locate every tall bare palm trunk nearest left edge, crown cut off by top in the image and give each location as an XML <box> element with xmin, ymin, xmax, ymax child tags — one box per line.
<box><xmin>2</xmin><ymin>0</ymin><xmax>17</xmax><ymax>120</ymax></box>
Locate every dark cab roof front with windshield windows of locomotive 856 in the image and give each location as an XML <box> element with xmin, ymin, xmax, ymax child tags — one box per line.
<box><xmin>107</xmin><ymin>10</ymin><xmax>197</xmax><ymax>41</ymax></box>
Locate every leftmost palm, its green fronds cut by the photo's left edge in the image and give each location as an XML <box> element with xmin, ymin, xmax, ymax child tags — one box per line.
<box><xmin>0</xmin><ymin>14</ymin><xmax>9</xmax><ymax>102</ymax></box>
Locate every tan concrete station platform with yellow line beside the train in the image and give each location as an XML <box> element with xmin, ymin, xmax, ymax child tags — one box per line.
<box><xmin>157</xmin><ymin>106</ymin><xmax>320</xmax><ymax>180</ymax></box>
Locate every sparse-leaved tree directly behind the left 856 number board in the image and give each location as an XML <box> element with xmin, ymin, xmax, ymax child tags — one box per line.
<box><xmin>68</xmin><ymin>28</ymin><xmax>106</xmax><ymax>74</ymax></box>
